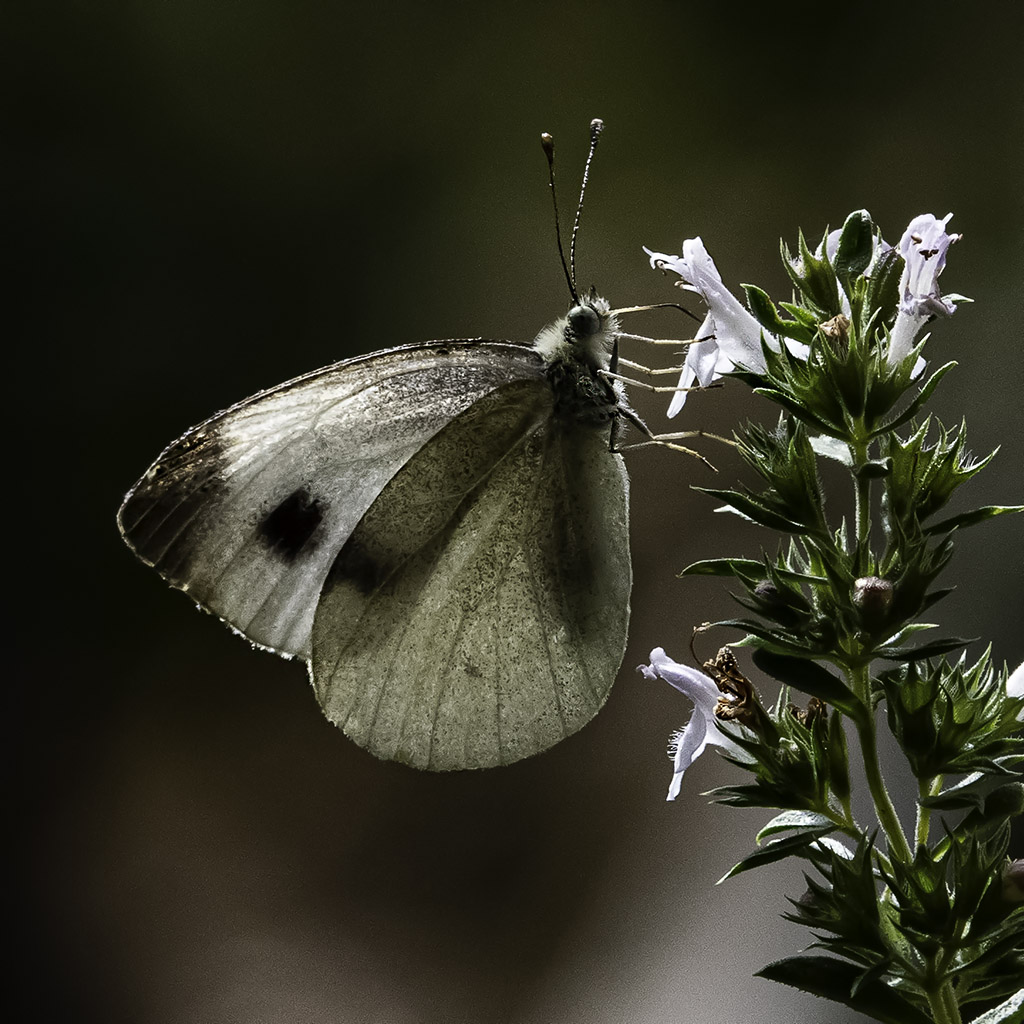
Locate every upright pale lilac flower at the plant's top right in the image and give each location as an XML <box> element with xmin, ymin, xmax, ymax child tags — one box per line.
<box><xmin>888</xmin><ymin>213</ymin><xmax>962</xmax><ymax>366</ymax></box>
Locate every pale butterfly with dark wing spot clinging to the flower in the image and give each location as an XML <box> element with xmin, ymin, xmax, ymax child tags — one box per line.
<box><xmin>118</xmin><ymin>122</ymin><xmax>647</xmax><ymax>770</ymax></box>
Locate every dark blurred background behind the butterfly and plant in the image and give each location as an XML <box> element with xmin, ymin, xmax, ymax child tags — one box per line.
<box><xmin>9</xmin><ymin>0</ymin><xmax>1024</xmax><ymax>1024</ymax></box>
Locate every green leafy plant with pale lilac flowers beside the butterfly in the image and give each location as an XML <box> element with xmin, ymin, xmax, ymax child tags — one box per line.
<box><xmin>642</xmin><ymin>211</ymin><xmax>1024</xmax><ymax>1024</ymax></box>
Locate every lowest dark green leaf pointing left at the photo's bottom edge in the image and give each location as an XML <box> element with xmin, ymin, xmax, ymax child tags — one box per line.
<box><xmin>757</xmin><ymin>956</ymin><xmax>932</xmax><ymax>1024</ymax></box>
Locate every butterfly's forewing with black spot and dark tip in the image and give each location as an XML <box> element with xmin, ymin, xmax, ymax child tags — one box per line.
<box><xmin>119</xmin><ymin>341</ymin><xmax>544</xmax><ymax>657</ymax></box>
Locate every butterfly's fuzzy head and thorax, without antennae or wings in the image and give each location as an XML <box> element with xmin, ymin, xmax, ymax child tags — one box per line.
<box><xmin>534</xmin><ymin>296</ymin><xmax>622</xmax><ymax>423</ymax></box>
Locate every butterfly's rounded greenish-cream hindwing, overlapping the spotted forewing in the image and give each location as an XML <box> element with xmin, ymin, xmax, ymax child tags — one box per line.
<box><xmin>311</xmin><ymin>379</ymin><xmax>631</xmax><ymax>769</ymax></box>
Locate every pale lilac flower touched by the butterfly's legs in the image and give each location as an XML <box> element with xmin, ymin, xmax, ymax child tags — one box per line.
<box><xmin>644</xmin><ymin>238</ymin><xmax>778</xmax><ymax>417</ymax></box>
